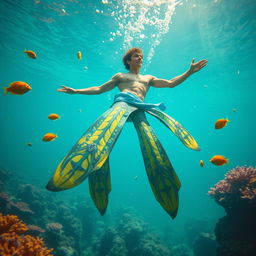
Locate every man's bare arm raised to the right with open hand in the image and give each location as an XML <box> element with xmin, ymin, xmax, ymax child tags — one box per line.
<box><xmin>151</xmin><ymin>59</ymin><xmax>208</xmax><ymax>88</ymax></box>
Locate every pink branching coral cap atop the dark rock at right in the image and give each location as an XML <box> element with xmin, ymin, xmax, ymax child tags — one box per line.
<box><xmin>208</xmin><ymin>166</ymin><xmax>256</xmax><ymax>208</ymax></box>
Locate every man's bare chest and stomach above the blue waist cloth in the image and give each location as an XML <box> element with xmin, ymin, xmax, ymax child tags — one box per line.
<box><xmin>116</xmin><ymin>73</ymin><xmax>153</xmax><ymax>101</ymax></box>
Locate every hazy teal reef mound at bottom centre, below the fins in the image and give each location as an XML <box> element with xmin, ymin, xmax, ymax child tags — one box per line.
<box><xmin>93</xmin><ymin>213</ymin><xmax>170</xmax><ymax>256</ymax></box>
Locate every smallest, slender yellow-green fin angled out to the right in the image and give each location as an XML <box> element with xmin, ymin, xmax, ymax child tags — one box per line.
<box><xmin>147</xmin><ymin>108</ymin><xmax>200</xmax><ymax>151</ymax></box>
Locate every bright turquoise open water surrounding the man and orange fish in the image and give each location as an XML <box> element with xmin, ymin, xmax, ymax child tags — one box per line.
<box><xmin>0</xmin><ymin>0</ymin><xmax>256</xmax><ymax>254</ymax></box>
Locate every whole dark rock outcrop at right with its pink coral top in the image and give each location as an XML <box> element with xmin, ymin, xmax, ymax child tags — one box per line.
<box><xmin>209</xmin><ymin>166</ymin><xmax>256</xmax><ymax>256</ymax></box>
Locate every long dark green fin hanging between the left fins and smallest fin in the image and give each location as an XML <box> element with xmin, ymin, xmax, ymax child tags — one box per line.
<box><xmin>131</xmin><ymin>110</ymin><xmax>181</xmax><ymax>218</ymax></box>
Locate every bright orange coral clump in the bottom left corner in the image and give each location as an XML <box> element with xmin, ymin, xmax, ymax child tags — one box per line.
<box><xmin>0</xmin><ymin>215</ymin><xmax>53</xmax><ymax>256</ymax></box>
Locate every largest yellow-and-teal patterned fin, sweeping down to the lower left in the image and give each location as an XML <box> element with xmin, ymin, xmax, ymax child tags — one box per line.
<box><xmin>46</xmin><ymin>102</ymin><xmax>137</xmax><ymax>191</ymax></box>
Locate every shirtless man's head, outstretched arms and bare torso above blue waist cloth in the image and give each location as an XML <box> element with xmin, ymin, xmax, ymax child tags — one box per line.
<box><xmin>58</xmin><ymin>48</ymin><xmax>207</xmax><ymax>101</ymax></box>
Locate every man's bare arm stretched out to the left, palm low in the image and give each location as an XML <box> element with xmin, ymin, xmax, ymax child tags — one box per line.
<box><xmin>57</xmin><ymin>73</ymin><xmax>119</xmax><ymax>95</ymax></box>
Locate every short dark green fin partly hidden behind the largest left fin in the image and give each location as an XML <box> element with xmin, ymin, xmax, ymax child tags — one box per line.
<box><xmin>88</xmin><ymin>158</ymin><xmax>111</xmax><ymax>215</ymax></box>
